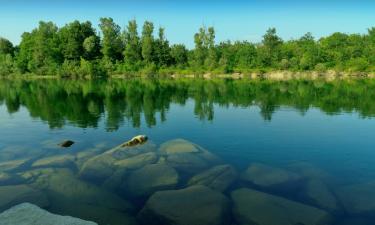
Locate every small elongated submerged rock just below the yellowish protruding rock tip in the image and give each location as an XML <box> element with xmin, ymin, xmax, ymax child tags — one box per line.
<box><xmin>115</xmin><ymin>152</ymin><xmax>158</xmax><ymax>169</ymax></box>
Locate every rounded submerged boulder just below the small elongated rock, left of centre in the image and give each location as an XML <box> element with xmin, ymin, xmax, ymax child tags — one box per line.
<box><xmin>124</xmin><ymin>164</ymin><xmax>179</xmax><ymax>197</ymax></box>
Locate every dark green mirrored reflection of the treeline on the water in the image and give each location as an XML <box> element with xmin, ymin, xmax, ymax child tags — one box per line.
<box><xmin>0</xmin><ymin>79</ymin><xmax>375</xmax><ymax>130</ymax></box>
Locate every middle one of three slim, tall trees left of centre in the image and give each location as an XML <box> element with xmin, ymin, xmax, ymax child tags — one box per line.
<box><xmin>141</xmin><ymin>21</ymin><xmax>154</xmax><ymax>64</ymax></box>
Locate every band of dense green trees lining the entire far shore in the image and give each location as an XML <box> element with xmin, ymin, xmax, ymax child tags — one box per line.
<box><xmin>0</xmin><ymin>18</ymin><xmax>375</xmax><ymax>77</ymax></box>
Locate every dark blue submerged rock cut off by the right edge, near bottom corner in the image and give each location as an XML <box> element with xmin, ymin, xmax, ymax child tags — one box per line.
<box><xmin>337</xmin><ymin>181</ymin><xmax>375</xmax><ymax>215</ymax></box>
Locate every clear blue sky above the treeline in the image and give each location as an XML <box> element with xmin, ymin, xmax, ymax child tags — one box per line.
<box><xmin>0</xmin><ymin>0</ymin><xmax>375</xmax><ymax>47</ymax></box>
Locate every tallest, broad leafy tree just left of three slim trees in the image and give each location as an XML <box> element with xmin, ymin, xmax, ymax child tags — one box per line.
<box><xmin>99</xmin><ymin>18</ymin><xmax>124</xmax><ymax>61</ymax></box>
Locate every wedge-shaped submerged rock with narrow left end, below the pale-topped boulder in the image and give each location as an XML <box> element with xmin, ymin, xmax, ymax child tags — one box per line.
<box><xmin>188</xmin><ymin>165</ymin><xmax>237</xmax><ymax>191</ymax></box>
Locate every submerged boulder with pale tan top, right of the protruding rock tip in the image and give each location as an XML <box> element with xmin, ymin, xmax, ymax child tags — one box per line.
<box><xmin>159</xmin><ymin>139</ymin><xmax>221</xmax><ymax>174</ymax></box>
